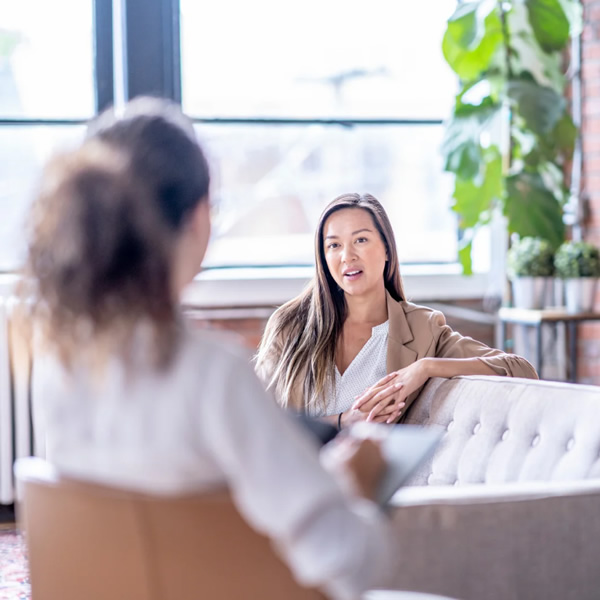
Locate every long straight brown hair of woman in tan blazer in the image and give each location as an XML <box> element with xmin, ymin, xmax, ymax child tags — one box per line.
<box><xmin>256</xmin><ymin>194</ymin><xmax>405</xmax><ymax>410</ymax></box>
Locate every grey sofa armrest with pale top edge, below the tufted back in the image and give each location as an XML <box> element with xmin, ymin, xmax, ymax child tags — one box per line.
<box><xmin>391</xmin><ymin>481</ymin><xmax>600</xmax><ymax>600</ymax></box>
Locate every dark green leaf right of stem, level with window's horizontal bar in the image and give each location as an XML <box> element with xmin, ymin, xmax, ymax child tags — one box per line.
<box><xmin>508</xmin><ymin>79</ymin><xmax>567</xmax><ymax>135</ymax></box>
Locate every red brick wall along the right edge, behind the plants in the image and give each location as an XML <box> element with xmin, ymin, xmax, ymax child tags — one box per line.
<box><xmin>578</xmin><ymin>0</ymin><xmax>600</xmax><ymax>385</ymax></box>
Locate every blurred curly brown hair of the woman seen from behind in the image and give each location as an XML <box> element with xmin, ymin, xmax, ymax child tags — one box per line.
<box><xmin>20</xmin><ymin>98</ymin><xmax>209</xmax><ymax>367</ymax></box>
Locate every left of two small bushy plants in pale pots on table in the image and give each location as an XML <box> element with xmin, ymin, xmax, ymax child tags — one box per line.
<box><xmin>507</xmin><ymin>237</ymin><xmax>554</xmax><ymax>308</ymax></box>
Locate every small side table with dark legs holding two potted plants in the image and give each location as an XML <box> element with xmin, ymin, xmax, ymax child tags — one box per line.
<box><xmin>498</xmin><ymin>307</ymin><xmax>600</xmax><ymax>382</ymax></box>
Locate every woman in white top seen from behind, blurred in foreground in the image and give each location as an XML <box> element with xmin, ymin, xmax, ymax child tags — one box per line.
<box><xmin>23</xmin><ymin>98</ymin><xmax>400</xmax><ymax>598</ymax></box>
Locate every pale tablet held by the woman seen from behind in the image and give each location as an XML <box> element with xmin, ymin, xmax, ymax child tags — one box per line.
<box><xmin>351</xmin><ymin>422</ymin><xmax>446</xmax><ymax>505</ymax></box>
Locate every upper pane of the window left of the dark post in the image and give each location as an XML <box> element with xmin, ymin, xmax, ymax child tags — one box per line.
<box><xmin>0</xmin><ymin>0</ymin><xmax>94</xmax><ymax>119</ymax></box>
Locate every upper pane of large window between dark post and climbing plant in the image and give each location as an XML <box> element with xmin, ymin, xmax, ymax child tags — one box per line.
<box><xmin>181</xmin><ymin>0</ymin><xmax>457</xmax><ymax>119</ymax></box>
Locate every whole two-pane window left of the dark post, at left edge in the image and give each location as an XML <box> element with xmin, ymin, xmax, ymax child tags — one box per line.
<box><xmin>0</xmin><ymin>0</ymin><xmax>95</xmax><ymax>271</ymax></box>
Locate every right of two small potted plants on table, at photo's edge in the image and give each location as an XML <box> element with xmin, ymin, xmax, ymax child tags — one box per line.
<box><xmin>554</xmin><ymin>241</ymin><xmax>600</xmax><ymax>312</ymax></box>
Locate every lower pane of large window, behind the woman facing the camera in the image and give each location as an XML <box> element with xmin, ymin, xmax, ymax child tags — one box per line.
<box><xmin>197</xmin><ymin>124</ymin><xmax>457</xmax><ymax>266</ymax></box>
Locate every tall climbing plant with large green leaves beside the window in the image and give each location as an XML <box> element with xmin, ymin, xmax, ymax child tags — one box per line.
<box><xmin>442</xmin><ymin>0</ymin><xmax>581</xmax><ymax>273</ymax></box>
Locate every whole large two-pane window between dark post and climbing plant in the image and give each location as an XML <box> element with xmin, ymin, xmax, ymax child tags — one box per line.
<box><xmin>181</xmin><ymin>0</ymin><xmax>457</xmax><ymax>266</ymax></box>
